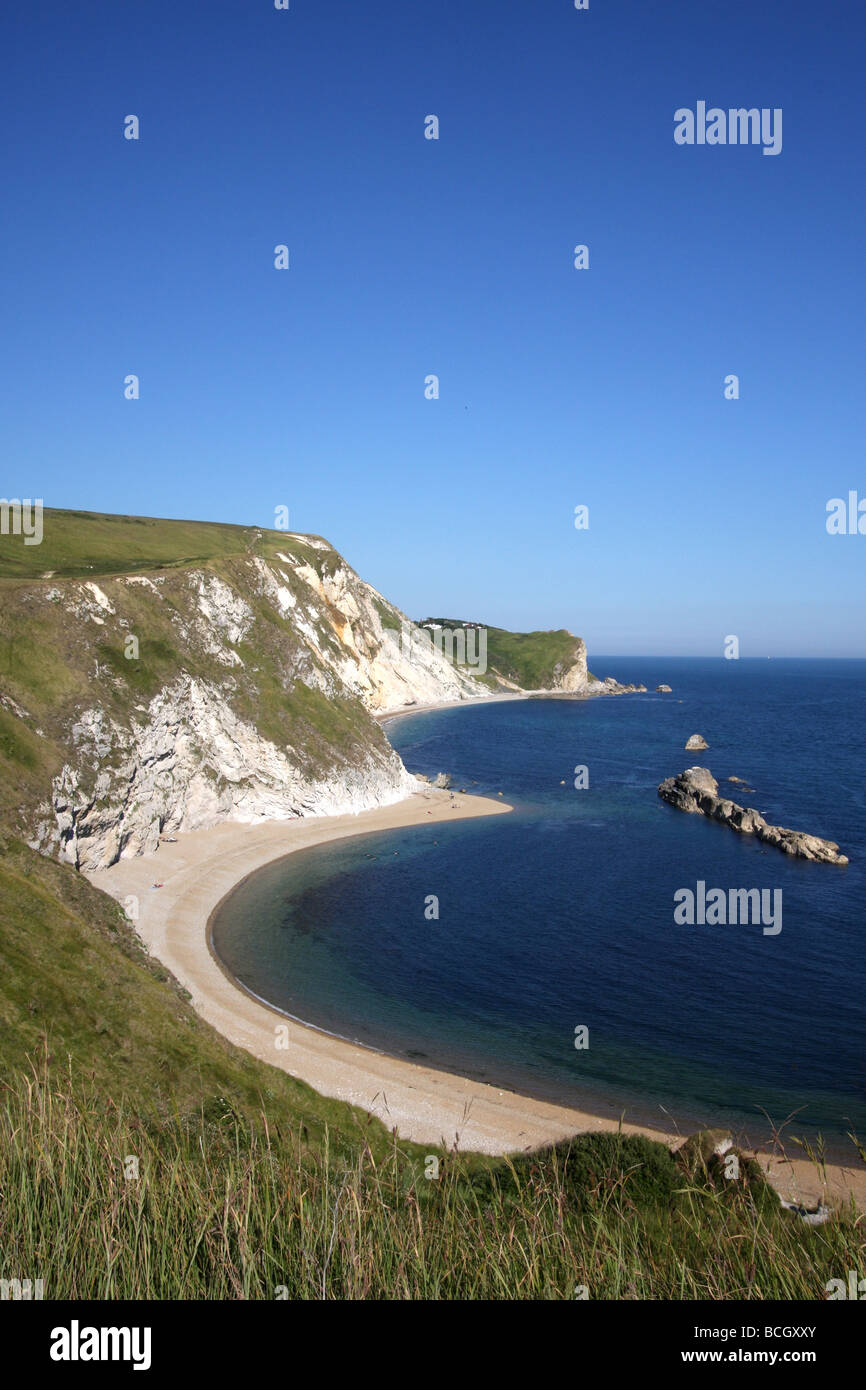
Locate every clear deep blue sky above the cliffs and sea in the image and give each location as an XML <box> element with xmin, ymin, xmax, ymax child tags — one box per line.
<box><xmin>0</xmin><ymin>0</ymin><xmax>866</xmax><ymax>656</ymax></box>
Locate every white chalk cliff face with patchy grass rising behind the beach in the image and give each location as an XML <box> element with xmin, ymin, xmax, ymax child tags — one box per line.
<box><xmin>0</xmin><ymin>531</ymin><xmax>587</xmax><ymax>870</ymax></box>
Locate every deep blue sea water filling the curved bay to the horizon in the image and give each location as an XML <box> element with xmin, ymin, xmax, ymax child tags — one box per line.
<box><xmin>213</xmin><ymin>657</ymin><xmax>866</xmax><ymax>1156</ymax></box>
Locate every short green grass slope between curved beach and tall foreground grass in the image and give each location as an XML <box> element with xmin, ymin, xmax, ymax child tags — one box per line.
<box><xmin>0</xmin><ymin>837</ymin><xmax>397</xmax><ymax>1152</ymax></box>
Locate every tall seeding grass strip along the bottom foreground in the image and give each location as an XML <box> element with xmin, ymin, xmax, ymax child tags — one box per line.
<box><xmin>0</xmin><ymin>1074</ymin><xmax>865</xmax><ymax>1300</ymax></box>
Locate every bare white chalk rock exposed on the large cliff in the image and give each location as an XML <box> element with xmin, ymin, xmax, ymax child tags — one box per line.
<box><xmin>32</xmin><ymin>538</ymin><xmax>489</xmax><ymax>869</ymax></box>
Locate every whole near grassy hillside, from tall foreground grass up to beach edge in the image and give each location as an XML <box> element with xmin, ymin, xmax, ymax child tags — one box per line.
<box><xmin>0</xmin><ymin>840</ymin><xmax>866</xmax><ymax>1300</ymax></box>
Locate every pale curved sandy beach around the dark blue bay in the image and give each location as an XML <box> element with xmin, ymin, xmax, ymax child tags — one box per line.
<box><xmin>89</xmin><ymin>788</ymin><xmax>866</xmax><ymax>1204</ymax></box>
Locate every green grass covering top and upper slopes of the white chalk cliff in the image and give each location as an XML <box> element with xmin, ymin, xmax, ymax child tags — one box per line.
<box><xmin>0</xmin><ymin>510</ymin><xmax>386</xmax><ymax>838</ymax></box>
